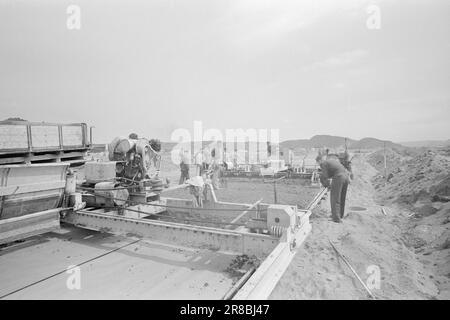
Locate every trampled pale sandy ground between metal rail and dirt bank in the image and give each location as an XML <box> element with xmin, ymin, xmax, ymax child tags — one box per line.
<box><xmin>271</xmin><ymin>156</ymin><xmax>450</xmax><ymax>299</ymax></box>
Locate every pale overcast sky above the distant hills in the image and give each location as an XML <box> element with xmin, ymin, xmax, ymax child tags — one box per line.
<box><xmin>0</xmin><ymin>0</ymin><xmax>450</xmax><ymax>142</ymax></box>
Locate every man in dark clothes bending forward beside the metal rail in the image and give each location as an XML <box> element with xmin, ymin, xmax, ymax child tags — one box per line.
<box><xmin>316</xmin><ymin>155</ymin><xmax>350</xmax><ymax>222</ymax></box>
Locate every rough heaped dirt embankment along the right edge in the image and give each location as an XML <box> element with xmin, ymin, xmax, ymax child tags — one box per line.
<box><xmin>369</xmin><ymin>148</ymin><xmax>450</xmax><ymax>299</ymax></box>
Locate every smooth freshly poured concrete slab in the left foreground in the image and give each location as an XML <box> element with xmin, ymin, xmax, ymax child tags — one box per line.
<box><xmin>0</xmin><ymin>227</ymin><xmax>235</xmax><ymax>299</ymax></box>
